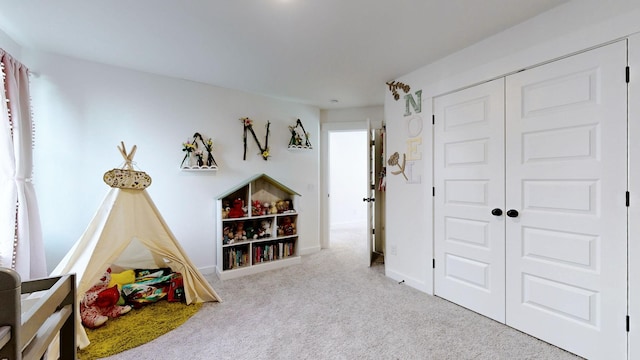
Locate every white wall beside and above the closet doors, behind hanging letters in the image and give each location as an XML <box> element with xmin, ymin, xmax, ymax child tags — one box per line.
<box><xmin>385</xmin><ymin>0</ymin><xmax>640</xmax><ymax>293</ymax></box>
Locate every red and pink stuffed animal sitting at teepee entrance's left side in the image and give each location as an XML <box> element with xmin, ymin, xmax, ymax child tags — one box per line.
<box><xmin>80</xmin><ymin>268</ymin><xmax>131</xmax><ymax>329</ymax></box>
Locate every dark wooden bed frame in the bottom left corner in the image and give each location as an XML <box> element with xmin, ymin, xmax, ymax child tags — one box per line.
<box><xmin>0</xmin><ymin>268</ymin><xmax>77</xmax><ymax>360</ymax></box>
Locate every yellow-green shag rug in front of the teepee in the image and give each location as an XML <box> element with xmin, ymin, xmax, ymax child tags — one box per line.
<box><xmin>78</xmin><ymin>301</ymin><xmax>202</xmax><ymax>360</ymax></box>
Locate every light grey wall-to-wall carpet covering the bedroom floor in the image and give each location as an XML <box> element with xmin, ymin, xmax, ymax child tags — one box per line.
<box><xmin>102</xmin><ymin>230</ymin><xmax>579</xmax><ymax>360</ymax></box>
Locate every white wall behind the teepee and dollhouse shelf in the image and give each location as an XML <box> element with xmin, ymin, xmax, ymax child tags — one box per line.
<box><xmin>0</xmin><ymin>45</ymin><xmax>320</xmax><ymax>272</ymax></box>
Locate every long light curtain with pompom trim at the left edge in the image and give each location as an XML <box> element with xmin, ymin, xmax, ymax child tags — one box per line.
<box><xmin>0</xmin><ymin>49</ymin><xmax>47</xmax><ymax>280</ymax></box>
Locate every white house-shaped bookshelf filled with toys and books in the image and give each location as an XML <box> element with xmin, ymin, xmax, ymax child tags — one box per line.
<box><xmin>216</xmin><ymin>174</ymin><xmax>300</xmax><ymax>280</ymax></box>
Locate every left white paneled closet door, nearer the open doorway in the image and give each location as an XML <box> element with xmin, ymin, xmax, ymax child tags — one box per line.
<box><xmin>434</xmin><ymin>79</ymin><xmax>505</xmax><ymax>322</ymax></box>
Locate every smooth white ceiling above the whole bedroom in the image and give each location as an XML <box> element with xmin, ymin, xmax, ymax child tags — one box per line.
<box><xmin>0</xmin><ymin>0</ymin><xmax>567</xmax><ymax>109</ymax></box>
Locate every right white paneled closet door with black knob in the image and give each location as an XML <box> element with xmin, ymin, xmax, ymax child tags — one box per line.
<box><xmin>505</xmin><ymin>42</ymin><xmax>627</xmax><ymax>359</ymax></box>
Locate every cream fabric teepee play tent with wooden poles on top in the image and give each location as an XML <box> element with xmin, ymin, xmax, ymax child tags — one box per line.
<box><xmin>51</xmin><ymin>144</ymin><xmax>221</xmax><ymax>348</ymax></box>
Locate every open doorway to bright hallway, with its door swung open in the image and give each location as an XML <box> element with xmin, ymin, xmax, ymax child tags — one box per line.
<box><xmin>322</xmin><ymin>121</ymin><xmax>385</xmax><ymax>265</ymax></box>
